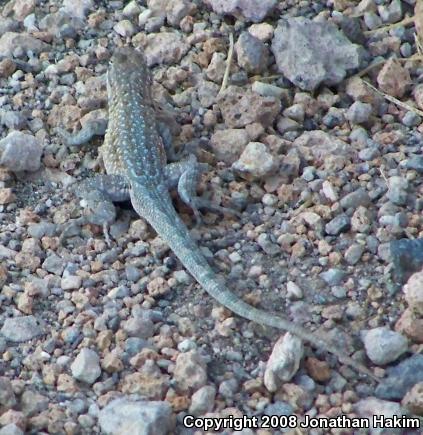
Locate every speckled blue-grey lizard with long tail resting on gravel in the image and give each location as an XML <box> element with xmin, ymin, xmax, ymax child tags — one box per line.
<box><xmin>60</xmin><ymin>47</ymin><xmax>379</xmax><ymax>381</ymax></box>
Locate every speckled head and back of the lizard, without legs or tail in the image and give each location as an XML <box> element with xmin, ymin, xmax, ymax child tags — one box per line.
<box><xmin>102</xmin><ymin>48</ymin><xmax>166</xmax><ymax>186</ymax></box>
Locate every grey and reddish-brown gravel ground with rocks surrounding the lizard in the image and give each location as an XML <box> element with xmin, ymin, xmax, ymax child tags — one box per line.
<box><xmin>0</xmin><ymin>0</ymin><xmax>423</xmax><ymax>435</ymax></box>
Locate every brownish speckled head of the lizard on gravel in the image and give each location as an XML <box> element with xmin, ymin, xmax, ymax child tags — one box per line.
<box><xmin>107</xmin><ymin>47</ymin><xmax>149</xmax><ymax>93</ymax></box>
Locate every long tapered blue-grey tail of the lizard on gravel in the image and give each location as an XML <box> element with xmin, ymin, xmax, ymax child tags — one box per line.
<box><xmin>131</xmin><ymin>191</ymin><xmax>380</xmax><ymax>381</ymax></box>
